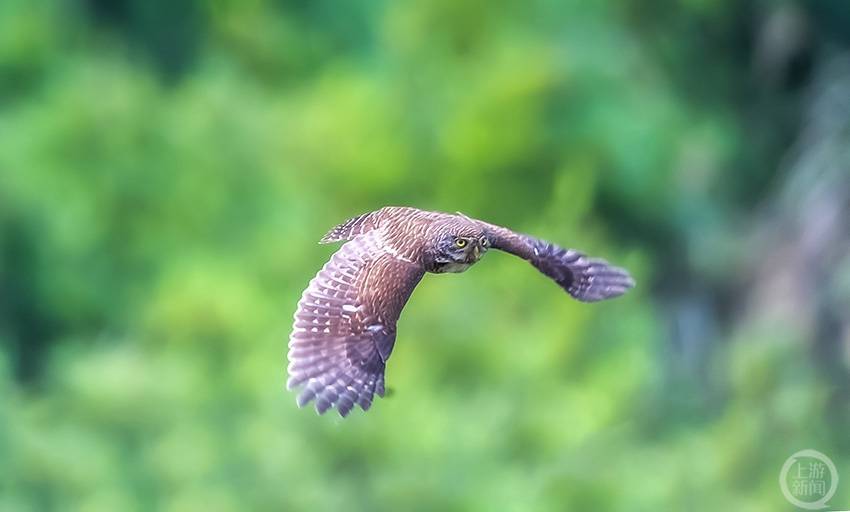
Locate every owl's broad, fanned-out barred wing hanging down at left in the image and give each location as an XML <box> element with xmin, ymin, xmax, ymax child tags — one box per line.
<box><xmin>286</xmin><ymin>230</ymin><xmax>424</xmax><ymax>417</ymax></box>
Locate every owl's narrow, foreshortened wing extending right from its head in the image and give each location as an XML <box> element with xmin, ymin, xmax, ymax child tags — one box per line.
<box><xmin>481</xmin><ymin>222</ymin><xmax>635</xmax><ymax>302</ymax></box>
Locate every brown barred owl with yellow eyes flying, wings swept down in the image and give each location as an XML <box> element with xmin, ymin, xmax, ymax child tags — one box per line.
<box><xmin>286</xmin><ymin>207</ymin><xmax>634</xmax><ymax>417</ymax></box>
